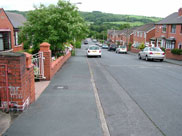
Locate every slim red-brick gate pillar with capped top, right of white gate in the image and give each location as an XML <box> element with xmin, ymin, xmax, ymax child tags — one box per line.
<box><xmin>39</xmin><ymin>42</ymin><xmax>51</xmax><ymax>80</ymax></box>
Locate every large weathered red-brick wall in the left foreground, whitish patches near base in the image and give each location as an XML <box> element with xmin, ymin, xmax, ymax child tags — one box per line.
<box><xmin>0</xmin><ymin>52</ymin><xmax>35</xmax><ymax>110</ymax></box>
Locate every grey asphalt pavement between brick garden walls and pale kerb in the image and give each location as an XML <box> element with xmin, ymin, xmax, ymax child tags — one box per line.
<box><xmin>4</xmin><ymin>51</ymin><xmax>102</xmax><ymax>136</ymax></box>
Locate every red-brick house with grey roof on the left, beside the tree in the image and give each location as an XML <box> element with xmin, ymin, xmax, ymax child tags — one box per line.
<box><xmin>0</xmin><ymin>8</ymin><xmax>26</xmax><ymax>52</ymax></box>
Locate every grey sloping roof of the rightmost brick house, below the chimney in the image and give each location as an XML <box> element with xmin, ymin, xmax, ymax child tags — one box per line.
<box><xmin>156</xmin><ymin>12</ymin><xmax>182</xmax><ymax>25</ymax></box>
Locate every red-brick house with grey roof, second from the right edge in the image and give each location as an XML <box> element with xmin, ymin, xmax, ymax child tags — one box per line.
<box><xmin>133</xmin><ymin>23</ymin><xmax>155</xmax><ymax>47</ymax></box>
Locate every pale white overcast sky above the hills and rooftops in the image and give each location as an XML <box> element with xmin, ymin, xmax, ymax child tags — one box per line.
<box><xmin>0</xmin><ymin>0</ymin><xmax>182</xmax><ymax>17</ymax></box>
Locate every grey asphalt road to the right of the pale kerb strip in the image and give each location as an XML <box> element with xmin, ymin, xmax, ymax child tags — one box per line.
<box><xmin>85</xmin><ymin>41</ymin><xmax>182</xmax><ymax>136</ymax></box>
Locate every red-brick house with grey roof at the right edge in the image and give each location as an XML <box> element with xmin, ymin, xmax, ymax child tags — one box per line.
<box><xmin>151</xmin><ymin>8</ymin><xmax>182</xmax><ymax>49</ymax></box>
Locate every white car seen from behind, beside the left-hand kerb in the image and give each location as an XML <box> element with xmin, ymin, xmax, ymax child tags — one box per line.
<box><xmin>86</xmin><ymin>45</ymin><xmax>102</xmax><ymax>58</ymax></box>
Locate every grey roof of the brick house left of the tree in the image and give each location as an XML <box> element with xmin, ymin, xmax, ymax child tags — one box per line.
<box><xmin>6</xmin><ymin>12</ymin><xmax>26</xmax><ymax>28</ymax></box>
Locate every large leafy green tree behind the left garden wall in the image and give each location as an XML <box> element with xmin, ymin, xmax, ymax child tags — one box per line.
<box><xmin>20</xmin><ymin>0</ymin><xmax>88</xmax><ymax>55</ymax></box>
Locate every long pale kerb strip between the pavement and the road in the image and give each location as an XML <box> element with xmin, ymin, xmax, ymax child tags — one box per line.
<box><xmin>87</xmin><ymin>59</ymin><xmax>110</xmax><ymax>136</ymax></box>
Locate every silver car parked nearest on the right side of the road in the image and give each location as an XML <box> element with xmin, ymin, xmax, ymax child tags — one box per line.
<box><xmin>138</xmin><ymin>47</ymin><xmax>165</xmax><ymax>61</ymax></box>
